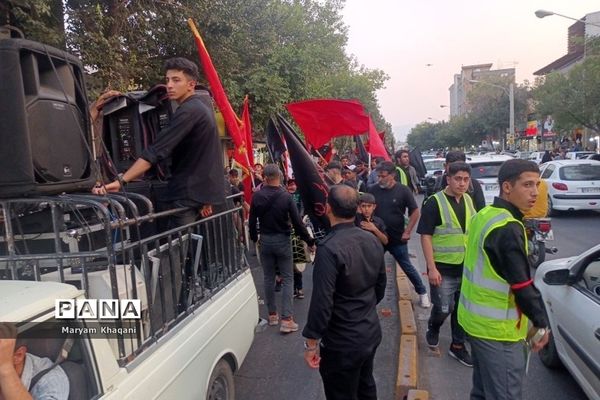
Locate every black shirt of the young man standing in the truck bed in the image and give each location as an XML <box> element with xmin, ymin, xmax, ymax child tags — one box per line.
<box><xmin>141</xmin><ymin>95</ymin><xmax>225</xmax><ymax>204</ymax></box>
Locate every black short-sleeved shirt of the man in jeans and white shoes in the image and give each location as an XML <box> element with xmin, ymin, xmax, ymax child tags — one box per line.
<box><xmin>369</xmin><ymin>183</ymin><xmax>418</xmax><ymax>247</ymax></box>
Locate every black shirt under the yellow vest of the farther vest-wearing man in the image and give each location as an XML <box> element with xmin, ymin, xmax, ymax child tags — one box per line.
<box><xmin>417</xmin><ymin>192</ymin><xmax>467</xmax><ymax>277</ymax></box>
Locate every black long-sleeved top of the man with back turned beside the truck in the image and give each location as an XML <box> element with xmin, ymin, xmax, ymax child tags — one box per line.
<box><xmin>248</xmin><ymin>185</ymin><xmax>314</xmax><ymax>246</ymax></box>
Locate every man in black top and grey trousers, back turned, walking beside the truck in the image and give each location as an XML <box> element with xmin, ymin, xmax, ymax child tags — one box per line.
<box><xmin>248</xmin><ymin>164</ymin><xmax>314</xmax><ymax>333</ymax></box>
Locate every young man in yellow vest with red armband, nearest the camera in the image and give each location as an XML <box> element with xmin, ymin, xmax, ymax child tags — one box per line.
<box><xmin>458</xmin><ymin>159</ymin><xmax>548</xmax><ymax>400</ymax></box>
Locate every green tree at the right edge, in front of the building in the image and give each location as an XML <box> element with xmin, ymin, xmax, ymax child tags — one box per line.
<box><xmin>533</xmin><ymin>39</ymin><xmax>600</xmax><ymax>133</ymax></box>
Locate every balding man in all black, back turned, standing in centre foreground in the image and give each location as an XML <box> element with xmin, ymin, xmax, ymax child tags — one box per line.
<box><xmin>302</xmin><ymin>185</ymin><xmax>386</xmax><ymax>400</ymax></box>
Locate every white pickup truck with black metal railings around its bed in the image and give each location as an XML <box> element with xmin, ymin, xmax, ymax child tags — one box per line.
<box><xmin>0</xmin><ymin>193</ymin><xmax>259</xmax><ymax>400</ymax></box>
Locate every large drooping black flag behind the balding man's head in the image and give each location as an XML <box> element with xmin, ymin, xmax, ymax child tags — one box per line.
<box><xmin>277</xmin><ymin>115</ymin><xmax>329</xmax><ymax>239</ymax></box>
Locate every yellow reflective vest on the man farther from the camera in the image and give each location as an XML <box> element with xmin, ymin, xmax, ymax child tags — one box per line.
<box><xmin>427</xmin><ymin>191</ymin><xmax>476</xmax><ymax>264</ymax></box>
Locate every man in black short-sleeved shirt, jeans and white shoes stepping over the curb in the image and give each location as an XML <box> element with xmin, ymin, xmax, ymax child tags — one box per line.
<box><xmin>369</xmin><ymin>161</ymin><xmax>431</xmax><ymax>308</ymax></box>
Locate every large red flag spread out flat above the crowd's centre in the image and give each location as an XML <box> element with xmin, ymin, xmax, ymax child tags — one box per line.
<box><xmin>286</xmin><ymin>99</ymin><xmax>369</xmax><ymax>148</ymax></box>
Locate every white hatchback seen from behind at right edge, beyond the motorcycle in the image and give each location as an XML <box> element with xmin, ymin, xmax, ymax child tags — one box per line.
<box><xmin>541</xmin><ymin>160</ymin><xmax>600</xmax><ymax>215</ymax></box>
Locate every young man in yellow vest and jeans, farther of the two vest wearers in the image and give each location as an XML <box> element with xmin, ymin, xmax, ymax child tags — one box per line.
<box><xmin>417</xmin><ymin>161</ymin><xmax>476</xmax><ymax>367</ymax></box>
